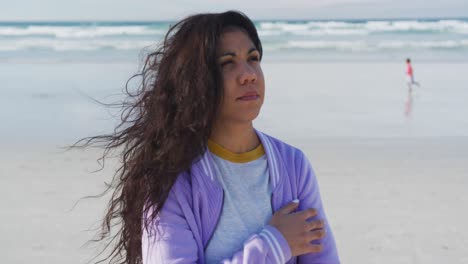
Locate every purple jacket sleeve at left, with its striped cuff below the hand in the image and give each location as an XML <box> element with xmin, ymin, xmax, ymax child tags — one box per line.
<box><xmin>142</xmin><ymin>185</ymin><xmax>291</xmax><ymax>264</ymax></box>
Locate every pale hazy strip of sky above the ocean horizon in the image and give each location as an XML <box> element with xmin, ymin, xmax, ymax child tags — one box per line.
<box><xmin>0</xmin><ymin>0</ymin><xmax>468</xmax><ymax>21</ymax></box>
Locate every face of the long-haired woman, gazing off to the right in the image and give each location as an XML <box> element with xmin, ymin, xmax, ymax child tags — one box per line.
<box><xmin>218</xmin><ymin>30</ymin><xmax>265</xmax><ymax>126</ymax></box>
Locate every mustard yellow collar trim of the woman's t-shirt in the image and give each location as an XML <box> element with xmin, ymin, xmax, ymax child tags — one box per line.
<box><xmin>208</xmin><ymin>139</ymin><xmax>265</xmax><ymax>163</ymax></box>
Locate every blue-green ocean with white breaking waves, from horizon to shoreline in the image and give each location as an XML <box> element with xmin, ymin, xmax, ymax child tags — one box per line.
<box><xmin>0</xmin><ymin>18</ymin><xmax>468</xmax><ymax>62</ymax></box>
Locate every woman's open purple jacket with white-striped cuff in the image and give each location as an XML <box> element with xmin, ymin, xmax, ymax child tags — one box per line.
<box><xmin>142</xmin><ymin>131</ymin><xmax>340</xmax><ymax>264</ymax></box>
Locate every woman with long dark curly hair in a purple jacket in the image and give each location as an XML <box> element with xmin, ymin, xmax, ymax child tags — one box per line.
<box><xmin>81</xmin><ymin>11</ymin><xmax>339</xmax><ymax>264</ymax></box>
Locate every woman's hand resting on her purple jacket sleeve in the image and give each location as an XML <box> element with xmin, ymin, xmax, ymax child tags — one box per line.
<box><xmin>269</xmin><ymin>200</ymin><xmax>325</xmax><ymax>257</ymax></box>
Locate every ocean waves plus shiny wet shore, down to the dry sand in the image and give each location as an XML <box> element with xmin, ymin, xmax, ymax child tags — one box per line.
<box><xmin>0</xmin><ymin>19</ymin><xmax>468</xmax><ymax>146</ymax></box>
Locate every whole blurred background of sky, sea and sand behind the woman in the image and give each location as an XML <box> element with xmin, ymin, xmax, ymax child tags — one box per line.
<box><xmin>0</xmin><ymin>0</ymin><xmax>468</xmax><ymax>263</ymax></box>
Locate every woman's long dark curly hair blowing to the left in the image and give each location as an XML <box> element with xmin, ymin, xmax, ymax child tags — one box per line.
<box><xmin>73</xmin><ymin>11</ymin><xmax>262</xmax><ymax>264</ymax></box>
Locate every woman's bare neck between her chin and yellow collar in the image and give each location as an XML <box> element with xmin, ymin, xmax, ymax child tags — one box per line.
<box><xmin>210</xmin><ymin>122</ymin><xmax>260</xmax><ymax>153</ymax></box>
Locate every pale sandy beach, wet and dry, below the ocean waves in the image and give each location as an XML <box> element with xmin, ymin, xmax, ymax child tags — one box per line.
<box><xmin>0</xmin><ymin>62</ymin><xmax>468</xmax><ymax>264</ymax></box>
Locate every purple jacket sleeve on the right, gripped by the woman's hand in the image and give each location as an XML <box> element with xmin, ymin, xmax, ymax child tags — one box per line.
<box><xmin>296</xmin><ymin>152</ymin><xmax>340</xmax><ymax>264</ymax></box>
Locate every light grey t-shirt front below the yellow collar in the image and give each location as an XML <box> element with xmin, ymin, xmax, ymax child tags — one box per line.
<box><xmin>205</xmin><ymin>147</ymin><xmax>272</xmax><ymax>264</ymax></box>
